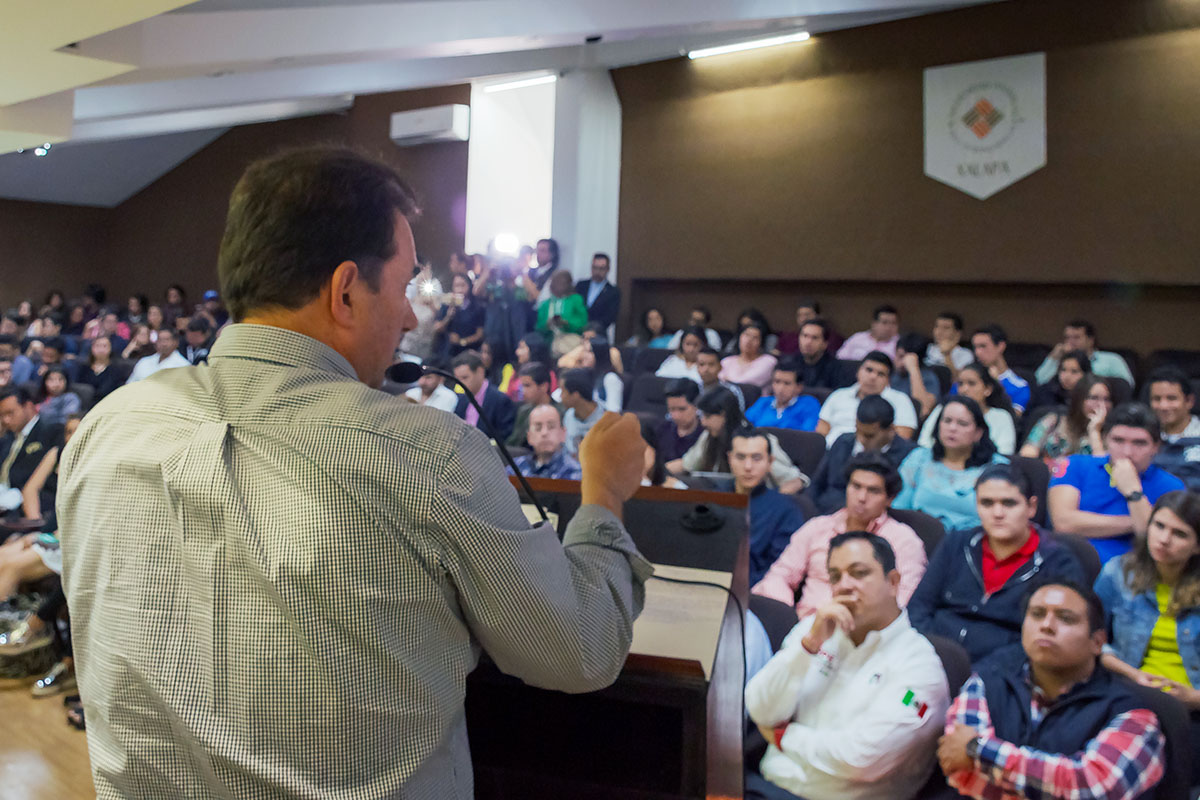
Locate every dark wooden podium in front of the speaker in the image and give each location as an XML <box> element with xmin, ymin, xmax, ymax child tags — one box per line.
<box><xmin>467</xmin><ymin>479</ymin><xmax>749</xmax><ymax>800</ymax></box>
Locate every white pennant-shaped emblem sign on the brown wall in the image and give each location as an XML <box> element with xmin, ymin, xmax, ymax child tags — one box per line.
<box><xmin>925</xmin><ymin>53</ymin><xmax>1046</xmax><ymax>200</ymax></box>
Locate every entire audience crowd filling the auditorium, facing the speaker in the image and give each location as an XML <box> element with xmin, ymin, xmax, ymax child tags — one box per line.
<box><xmin>7</xmin><ymin>256</ymin><xmax>1200</xmax><ymax>800</ymax></box>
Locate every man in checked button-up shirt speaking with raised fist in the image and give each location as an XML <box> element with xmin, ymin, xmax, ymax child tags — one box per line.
<box><xmin>59</xmin><ymin>149</ymin><xmax>649</xmax><ymax>800</ymax></box>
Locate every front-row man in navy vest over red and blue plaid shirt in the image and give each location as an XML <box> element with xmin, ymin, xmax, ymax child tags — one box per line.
<box><xmin>937</xmin><ymin>583</ymin><xmax>1165</xmax><ymax>800</ymax></box>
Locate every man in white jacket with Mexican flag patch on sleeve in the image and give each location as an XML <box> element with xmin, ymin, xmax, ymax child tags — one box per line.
<box><xmin>745</xmin><ymin>531</ymin><xmax>949</xmax><ymax>800</ymax></box>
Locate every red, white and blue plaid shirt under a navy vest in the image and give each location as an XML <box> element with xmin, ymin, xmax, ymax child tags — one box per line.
<box><xmin>946</xmin><ymin>664</ymin><xmax>1165</xmax><ymax>800</ymax></box>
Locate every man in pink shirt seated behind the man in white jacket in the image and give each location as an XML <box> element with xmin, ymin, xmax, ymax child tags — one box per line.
<box><xmin>751</xmin><ymin>453</ymin><xmax>925</xmax><ymax>619</ymax></box>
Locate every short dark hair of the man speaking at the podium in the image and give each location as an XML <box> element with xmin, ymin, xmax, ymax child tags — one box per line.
<box><xmin>217</xmin><ymin>148</ymin><xmax>416</xmax><ymax>321</ymax></box>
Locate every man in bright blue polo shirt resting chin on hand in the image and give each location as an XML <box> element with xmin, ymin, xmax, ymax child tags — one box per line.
<box><xmin>1049</xmin><ymin>403</ymin><xmax>1183</xmax><ymax>563</ymax></box>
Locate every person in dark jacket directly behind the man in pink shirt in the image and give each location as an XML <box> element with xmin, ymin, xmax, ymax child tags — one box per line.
<box><xmin>808</xmin><ymin>395</ymin><xmax>917</xmax><ymax>515</ymax></box>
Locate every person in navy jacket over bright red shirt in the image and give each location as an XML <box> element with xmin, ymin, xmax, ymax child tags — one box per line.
<box><xmin>908</xmin><ymin>464</ymin><xmax>1084</xmax><ymax>663</ymax></box>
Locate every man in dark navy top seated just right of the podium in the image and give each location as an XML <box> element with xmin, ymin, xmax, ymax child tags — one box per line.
<box><xmin>728</xmin><ymin>426</ymin><xmax>804</xmax><ymax>585</ymax></box>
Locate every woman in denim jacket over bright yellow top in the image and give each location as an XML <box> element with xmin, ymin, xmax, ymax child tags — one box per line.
<box><xmin>1096</xmin><ymin>491</ymin><xmax>1200</xmax><ymax>705</ymax></box>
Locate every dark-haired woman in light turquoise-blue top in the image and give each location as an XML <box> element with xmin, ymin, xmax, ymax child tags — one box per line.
<box><xmin>892</xmin><ymin>396</ymin><xmax>1008</xmax><ymax>530</ymax></box>
